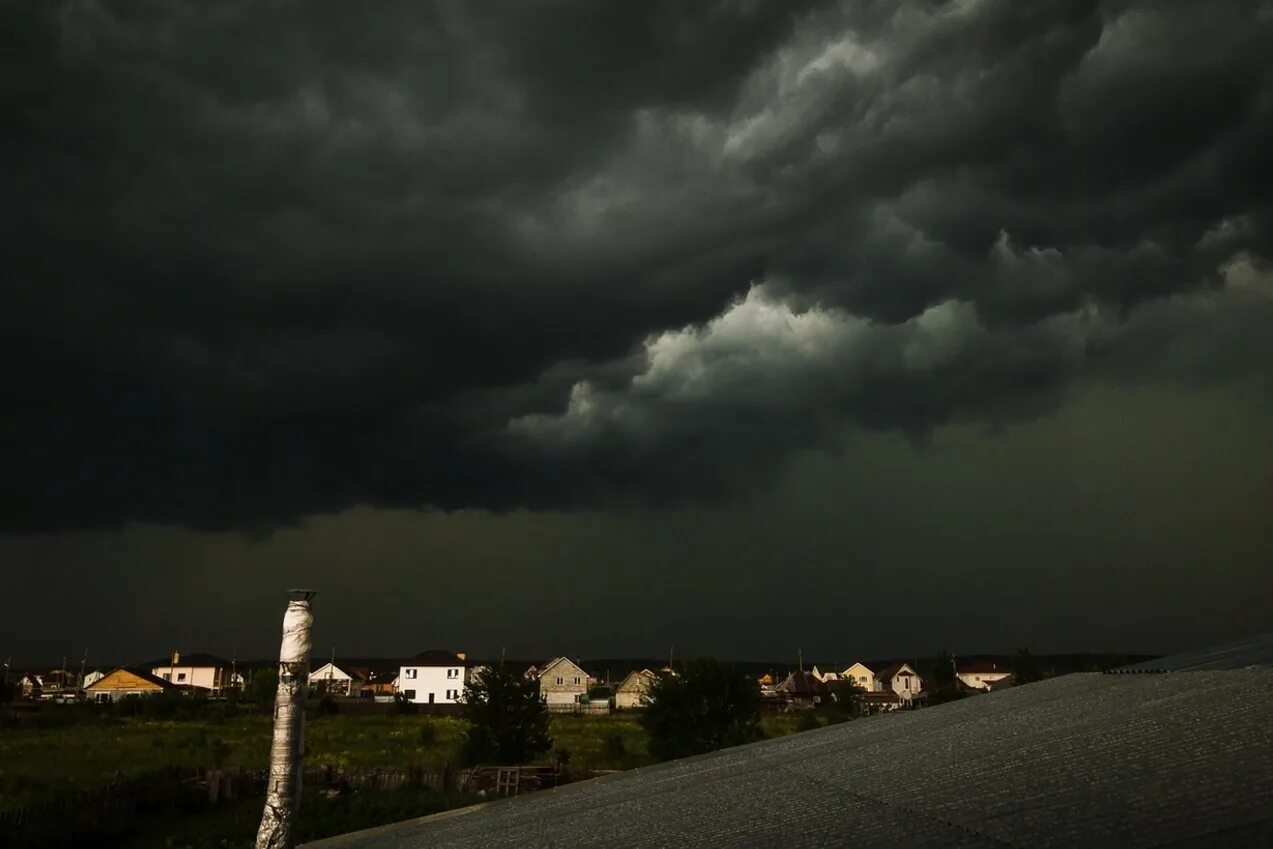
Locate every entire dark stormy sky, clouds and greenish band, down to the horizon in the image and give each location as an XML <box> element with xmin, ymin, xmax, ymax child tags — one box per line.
<box><xmin>0</xmin><ymin>0</ymin><xmax>1273</xmax><ymax>662</ymax></box>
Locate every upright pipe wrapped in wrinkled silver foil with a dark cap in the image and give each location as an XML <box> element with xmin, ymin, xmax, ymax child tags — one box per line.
<box><xmin>256</xmin><ymin>589</ymin><xmax>317</xmax><ymax>849</ymax></box>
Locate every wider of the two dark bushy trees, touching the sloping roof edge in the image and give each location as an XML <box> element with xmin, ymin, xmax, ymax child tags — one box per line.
<box><xmin>640</xmin><ymin>659</ymin><xmax>763</xmax><ymax>759</ymax></box>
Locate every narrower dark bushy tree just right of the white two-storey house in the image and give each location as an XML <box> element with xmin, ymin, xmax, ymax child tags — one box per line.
<box><xmin>465</xmin><ymin>667</ymin><xmax>552</xmax><ymax>764</ymax></box>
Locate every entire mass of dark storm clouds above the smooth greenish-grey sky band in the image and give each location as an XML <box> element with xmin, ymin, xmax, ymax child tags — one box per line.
<box><xmin>0</xmin><ymin>0</ymin><xmax>1273</xmax><ymax>531</ymax></box>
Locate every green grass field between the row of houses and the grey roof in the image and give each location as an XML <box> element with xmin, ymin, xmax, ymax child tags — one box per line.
<box><xmin>0</xmin><ymin>708</ymin><xmax>825</xmax><ymax>849</ymax></box>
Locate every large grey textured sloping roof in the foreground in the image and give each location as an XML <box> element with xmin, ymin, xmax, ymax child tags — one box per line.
<box><xmin>302</xmin><ymin>670</ymin><xmax>1273</xmax><ymax>849</ymax></box>
